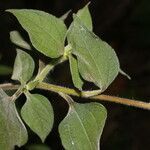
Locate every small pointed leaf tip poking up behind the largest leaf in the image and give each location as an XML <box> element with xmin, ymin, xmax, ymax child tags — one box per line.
<box><xmin>74</xmin><ymin>3</ymin><xmax>93</xmax><ymax>31</ymax></box>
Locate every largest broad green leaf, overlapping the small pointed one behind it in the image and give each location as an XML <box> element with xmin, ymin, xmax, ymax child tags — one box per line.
<box><xmin>67</xmin><ymin>17</ymin><xmax>120</xmax><ymax>92</ymax></box>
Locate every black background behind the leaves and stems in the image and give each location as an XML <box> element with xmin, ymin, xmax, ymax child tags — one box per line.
<box><xmin>0</xmin><ymin>0</ymin><xmax>150</xmax><ymax>150</ymax></box>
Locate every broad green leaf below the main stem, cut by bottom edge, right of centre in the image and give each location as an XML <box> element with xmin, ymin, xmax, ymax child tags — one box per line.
<box><xmin>59</xmin><ymin>102</ymin><xmax>107</xmax><ymax>150</ymax></box>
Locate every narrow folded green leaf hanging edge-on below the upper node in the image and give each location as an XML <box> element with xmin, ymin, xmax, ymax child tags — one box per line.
<box><xmin>69</xmin><ymin>55</ymin><xmax>83</xmax><ymax>90</ymax></box>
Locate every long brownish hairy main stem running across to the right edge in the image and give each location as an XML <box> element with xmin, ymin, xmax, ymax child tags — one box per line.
<box><xmin>0</xmin><ymin>82</ymin><xmax>150</xmax><ymax>110</ymax></box>
